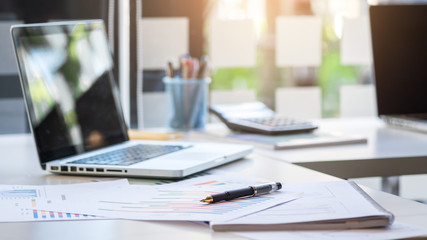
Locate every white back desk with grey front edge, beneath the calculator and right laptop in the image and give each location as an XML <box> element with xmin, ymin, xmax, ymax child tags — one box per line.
<box><xmin>252</xmin><ymin>118</ymin><xmax>427</xmax><ymax>179</ymax></box>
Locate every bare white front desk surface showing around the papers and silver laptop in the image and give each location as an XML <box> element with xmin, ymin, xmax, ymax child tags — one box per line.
<box><xmin>0</xmin><ymin>135</ymin><xmax>427</xmax><ymax>240</ymax></box>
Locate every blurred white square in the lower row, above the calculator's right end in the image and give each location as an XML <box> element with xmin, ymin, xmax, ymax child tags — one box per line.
<box><xmin>275</xmin><ymin>87</ymin><xmax>322</xmax><ymax>119</ymax></box>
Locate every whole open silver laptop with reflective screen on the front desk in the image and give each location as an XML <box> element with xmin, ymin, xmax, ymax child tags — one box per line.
<box><xmin>11</xmin><ymin>20</ymin><xmax>252</xmax><ymax>178</ymax></box>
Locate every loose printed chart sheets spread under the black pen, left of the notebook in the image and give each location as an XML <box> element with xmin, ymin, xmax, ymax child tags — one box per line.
<box><xmin>0</xmin><ymin>175</ymin><xmax>301</xmax><ymax>222</ymax></box>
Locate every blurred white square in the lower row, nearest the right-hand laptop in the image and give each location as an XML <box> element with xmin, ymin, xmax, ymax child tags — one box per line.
<box><xmin>340</xmin><ymin>84</ymin><xmax>377</xmax><ymax>118</ymax></box>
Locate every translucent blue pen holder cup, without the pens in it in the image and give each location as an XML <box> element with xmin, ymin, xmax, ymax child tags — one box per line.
<box><xmin>163</xmin><ymin>77</ymin><xmax>211</xmax><ymax>131</ymax></box>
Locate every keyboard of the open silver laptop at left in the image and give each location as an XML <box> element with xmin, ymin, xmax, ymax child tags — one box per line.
<box><xmin>68</xmin><ymin>144</ymin><xmax>184</xmax><ymax>166</ymax></box>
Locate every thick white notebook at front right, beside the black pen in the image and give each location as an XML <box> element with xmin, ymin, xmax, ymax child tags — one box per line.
<box><xmin>211</xmin><ymin>181</ymin><xmax>394</xmax><ymax>231</ymax></box>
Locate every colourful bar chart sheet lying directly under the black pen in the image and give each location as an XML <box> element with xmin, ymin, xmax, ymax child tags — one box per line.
<box><xmin>89</xmin><ymin>175</ymin><xmax>298</xmax><ymax>221</ymax></box>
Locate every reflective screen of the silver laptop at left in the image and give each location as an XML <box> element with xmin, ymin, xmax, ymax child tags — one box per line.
<box><xmin>12</xmin><ymin>21</ymin><xmax>128</xmax><ymax>167</ymax></box>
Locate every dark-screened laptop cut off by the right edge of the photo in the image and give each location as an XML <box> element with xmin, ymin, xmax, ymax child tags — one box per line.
<box><xmin>369</xmin><ymin>4</ymin><xmax>427</xmax><ymax>132</ymax></box>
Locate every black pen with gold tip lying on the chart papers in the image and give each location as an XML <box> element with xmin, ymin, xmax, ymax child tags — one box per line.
<box><xmin>200</xmin><ymin>182</ymin><xmax>282</xmax><ymax>203</ymax></box>
